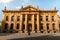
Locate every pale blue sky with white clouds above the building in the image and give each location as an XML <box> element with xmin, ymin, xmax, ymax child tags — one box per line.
<box><xmin>0</xmin><ymin>0</ymin><xmax>60</xmax><ymax>21</ymax></box>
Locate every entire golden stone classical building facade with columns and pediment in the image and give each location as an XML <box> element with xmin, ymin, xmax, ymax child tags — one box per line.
<box><xmin>2</xmin><ymin>5</ymin><xmax>59</xmax><ymax>33</ymax></box>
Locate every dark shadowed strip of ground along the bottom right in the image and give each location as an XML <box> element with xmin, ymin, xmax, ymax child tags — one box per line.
<box><xmin>11</xmin><ymin>36</ymin><xmax>60</xmax><ymax>40</ymax></box>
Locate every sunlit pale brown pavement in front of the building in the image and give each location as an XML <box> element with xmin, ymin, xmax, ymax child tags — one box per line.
<box><xmin>0</xmin><ymin>33</ymin><xmax>60</xmax><ymax>40</ymax></box>
